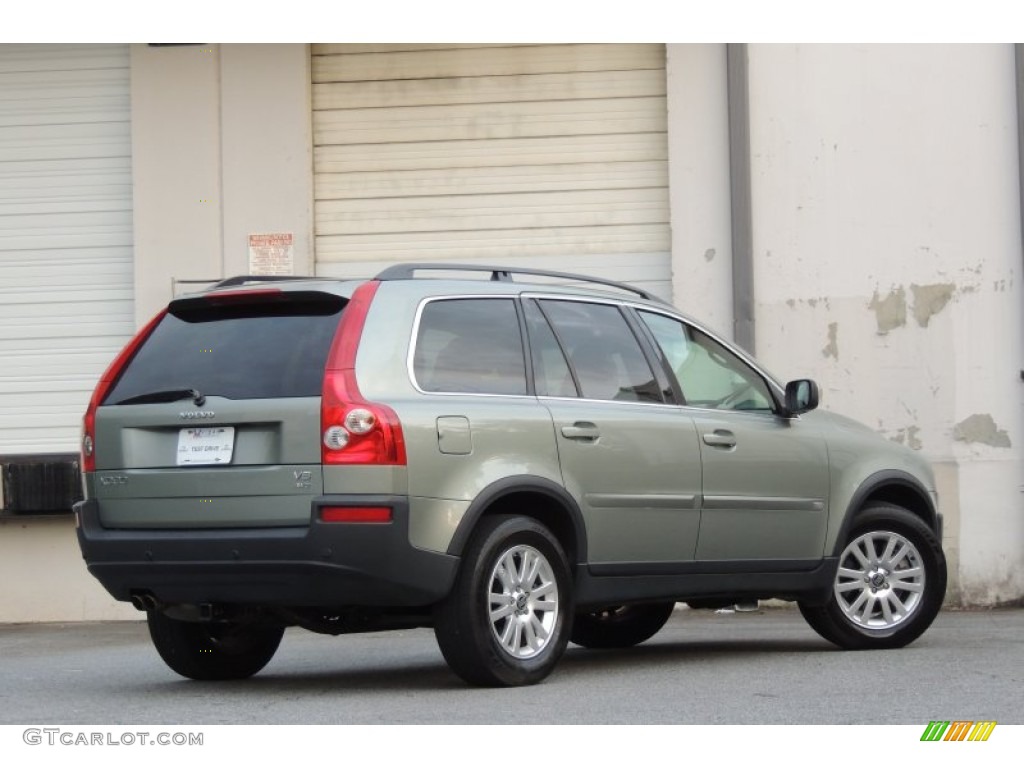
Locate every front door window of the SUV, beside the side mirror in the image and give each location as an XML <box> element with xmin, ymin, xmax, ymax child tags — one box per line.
<box><xmin>640</xmin><ymin>311</ymin><xmax>774</xmax><ymax>411</ymax></box>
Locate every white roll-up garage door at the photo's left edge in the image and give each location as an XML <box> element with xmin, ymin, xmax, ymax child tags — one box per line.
<box><xmin>0</xmin><ymin>45</ymin><xmax>133</xmax><ymax>455</ymax></box>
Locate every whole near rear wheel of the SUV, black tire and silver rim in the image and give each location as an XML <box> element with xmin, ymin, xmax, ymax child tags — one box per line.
<box><xmin>434</xmin><ymin>515</ymin><xmax>572</xmax><ymax>686</ymax></box>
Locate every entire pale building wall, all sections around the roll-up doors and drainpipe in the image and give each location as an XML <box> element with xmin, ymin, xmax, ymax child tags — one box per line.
<box><xmin>0</xmin><ymin>45</ymin><xmax>1024</xmax><ymax>621</ymax></box>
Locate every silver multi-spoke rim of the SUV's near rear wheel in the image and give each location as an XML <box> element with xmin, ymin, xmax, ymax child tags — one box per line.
<box><xmin>487</xmin><ymin>544</ymin><xmax>558</xmax><ymax>659</ymax></box>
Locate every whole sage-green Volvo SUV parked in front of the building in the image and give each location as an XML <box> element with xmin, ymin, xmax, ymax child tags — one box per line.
<box><xmin>76</xmin><ymin>264</ymin><xmax>946</xmax><ymax>685</ymax></box>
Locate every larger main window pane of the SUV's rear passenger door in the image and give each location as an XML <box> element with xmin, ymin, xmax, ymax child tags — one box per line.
<box><xmin>540</xmin><ymin>300</ymin><xmax>664</xmax><ymax>402</ymax></box>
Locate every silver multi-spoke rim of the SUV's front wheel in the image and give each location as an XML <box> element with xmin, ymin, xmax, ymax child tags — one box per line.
<box><xmin>834</xmin><ymin>530</ymin><xmax>925</xmax><ymax>632</ymax></box>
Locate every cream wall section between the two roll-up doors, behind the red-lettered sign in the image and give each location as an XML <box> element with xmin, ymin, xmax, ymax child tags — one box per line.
<box><xmin>131</xmin><ymin>45</ymin><xmax>313</xmax><ymax>324</ymax></box>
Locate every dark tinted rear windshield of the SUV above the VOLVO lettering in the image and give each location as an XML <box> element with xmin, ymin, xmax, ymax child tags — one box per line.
<box><xmin>103</xmin><ymin>294</ymin><xmax>346</xmax><ymax>404</ymax></box>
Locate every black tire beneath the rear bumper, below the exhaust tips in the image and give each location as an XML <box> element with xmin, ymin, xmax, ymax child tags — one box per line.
<box><xmin>147</xmin><ymin>610</ymin><xmax>285</xmax><ymax>680</ymax></box>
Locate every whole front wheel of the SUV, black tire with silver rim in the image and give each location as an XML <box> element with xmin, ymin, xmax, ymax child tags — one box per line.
<box><xmin>800</xmin><ymin>503</ymin><xmax>946</xmax><ymax>650</ymax></box>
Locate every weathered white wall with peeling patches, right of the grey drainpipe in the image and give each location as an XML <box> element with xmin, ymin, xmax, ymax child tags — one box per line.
<box><xmin>750</xmin><ymin>45</ymin><xmax>1024</xmax><ymax>604</ymax></box>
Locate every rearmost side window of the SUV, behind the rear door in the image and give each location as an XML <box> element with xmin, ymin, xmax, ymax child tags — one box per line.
<box><xmin>413</xmin><ymin>299</ymin><xmax>526</xmax><ymax>394</ymax></box>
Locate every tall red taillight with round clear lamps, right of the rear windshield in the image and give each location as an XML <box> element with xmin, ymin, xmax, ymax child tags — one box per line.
<box><xmin>321</xmin><ymin>281</ymin><xmax>406</xmax><ymax>465</ymax></box>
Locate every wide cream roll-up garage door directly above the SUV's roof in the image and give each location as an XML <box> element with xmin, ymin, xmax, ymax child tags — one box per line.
<box><xmin>312</xmin><ymin>44</ymin><xmax>671</xmax><ymax>298</ymax></box>
